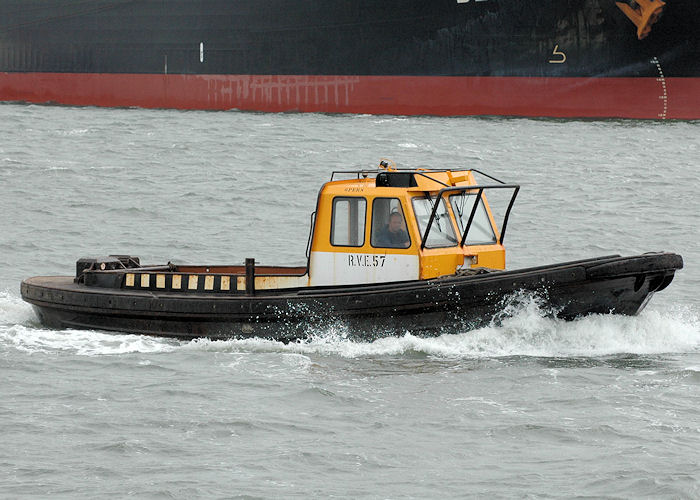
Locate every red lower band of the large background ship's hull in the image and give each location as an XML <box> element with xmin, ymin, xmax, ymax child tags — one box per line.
<box><xmin>0</xmin><ymin>73</ymin><xmax>700</xmax><ymax>119</ymax></box>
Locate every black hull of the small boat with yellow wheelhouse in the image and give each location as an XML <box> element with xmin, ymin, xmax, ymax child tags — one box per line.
<box><xmin>21</xmin><ymin>253</ymin><xmax>683</xmax><ymax>341</ymax></box>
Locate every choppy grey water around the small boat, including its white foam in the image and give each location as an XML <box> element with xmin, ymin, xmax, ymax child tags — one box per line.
<box><xmin>0</xmin><ymin>105</ymin><xmax>700</xmax><ymax>499</ymax></box>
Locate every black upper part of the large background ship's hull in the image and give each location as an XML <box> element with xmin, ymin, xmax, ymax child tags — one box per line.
<box><xmin>0</xmin><ymin>0</ymin><xmax>700</xmax><ymax>77</ymax></box>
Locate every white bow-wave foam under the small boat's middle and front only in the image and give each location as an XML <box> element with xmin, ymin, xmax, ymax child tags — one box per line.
<box><xmin>175</xmin><ymin>301</ymin><xmax>700</xmax><ymax>359</ymax></box>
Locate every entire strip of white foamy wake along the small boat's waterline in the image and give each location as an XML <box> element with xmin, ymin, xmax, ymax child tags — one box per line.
<box><xmin>0</xmin><ymin>292</ymin><xmax>700</xmax><ymax>359</ymax></box>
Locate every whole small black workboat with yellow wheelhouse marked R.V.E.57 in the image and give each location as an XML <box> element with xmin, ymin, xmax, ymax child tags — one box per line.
<box><xmin>21</xmin><ymin>161</ymin><xmax>683</xmax><ymax>342</ymax></box>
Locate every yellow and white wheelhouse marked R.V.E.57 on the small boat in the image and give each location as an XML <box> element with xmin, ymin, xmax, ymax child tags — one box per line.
<box><xmin>309</xmin><ymin>163</ymin><xmax>520</xmax><ymax>286</ymax></box>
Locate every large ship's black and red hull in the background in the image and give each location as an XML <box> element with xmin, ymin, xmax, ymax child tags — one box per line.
<box><xmin>0</xmin><ymin>0</ymin><xmax>700</xmax><ymax>119</ymax></box>
